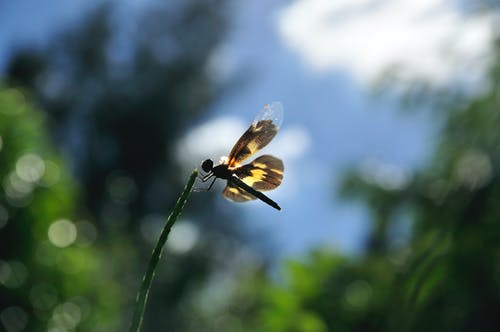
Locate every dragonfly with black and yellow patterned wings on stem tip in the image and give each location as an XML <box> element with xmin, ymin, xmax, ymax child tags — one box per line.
<box><xmin>201</xmin><ymin>102</ymin><xmax>284</xmax><ymax>210</ymax></box>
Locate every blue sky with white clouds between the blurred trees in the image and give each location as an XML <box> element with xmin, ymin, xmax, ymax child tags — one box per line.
<box><xmin>0</xmin><ymin>0</ymin><xmax>491</xmax><ymax>256</ymax></box>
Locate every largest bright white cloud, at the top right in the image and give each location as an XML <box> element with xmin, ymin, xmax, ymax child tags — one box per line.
<box><xmin>278</xmin><ymin>0</ymin><xmax>493</xmax><ymax>84</ymax></box>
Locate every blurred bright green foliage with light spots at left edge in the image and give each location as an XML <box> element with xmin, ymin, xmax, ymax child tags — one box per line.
<box><xmin>0</xmin><ymin>87</ymin><xmax>123</xmax><ymax>331</ymax></box>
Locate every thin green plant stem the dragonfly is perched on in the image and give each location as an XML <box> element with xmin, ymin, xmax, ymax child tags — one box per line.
<box><xmin>129</xmin><ymin>169</ymin><xmax>198</xmax><ymax>332</ymax></box>
